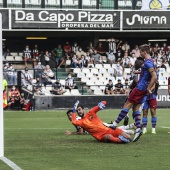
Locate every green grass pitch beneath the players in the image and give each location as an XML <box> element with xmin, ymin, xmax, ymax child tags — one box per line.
<box><xmin>0</xmin><ymin>109</ymin><xmax>170</xmax><ymax>170</ymax></box>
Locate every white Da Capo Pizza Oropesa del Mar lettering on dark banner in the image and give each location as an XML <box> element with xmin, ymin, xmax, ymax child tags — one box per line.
<box><xmin>14</xmin><ymin>10</ymin><xmax>119</xmax><ymax>29</ymax></box>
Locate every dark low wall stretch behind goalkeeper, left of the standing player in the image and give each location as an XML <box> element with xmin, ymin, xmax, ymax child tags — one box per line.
<box><xmin>35</xmin><ymin>95</ymin><xmax>126</xmax><ymax>110</ymax></box>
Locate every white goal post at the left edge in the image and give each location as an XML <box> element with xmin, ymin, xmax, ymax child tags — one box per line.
<box><xmin>0</xmin><ymin>13</ymin><xmax>4</xmax><ymax>157</ymax></box>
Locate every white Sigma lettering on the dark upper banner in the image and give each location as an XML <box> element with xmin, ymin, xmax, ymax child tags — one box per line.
<box><xmin>126</xmin><ymin>14</ymin><xmax>167</xmax><ymax>25</ymax></box>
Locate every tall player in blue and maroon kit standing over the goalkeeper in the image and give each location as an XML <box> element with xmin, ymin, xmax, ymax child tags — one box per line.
<box><xmin>110</xmin><ymin>44</ymin><xmax>157</xmax><ymax>142</ymax></box>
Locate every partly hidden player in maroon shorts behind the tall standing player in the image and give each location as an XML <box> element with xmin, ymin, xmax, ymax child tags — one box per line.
<box><xmin>142</xmin><ymin>82</ymin><xmax>159</xmax><ymax>134</ymax></box>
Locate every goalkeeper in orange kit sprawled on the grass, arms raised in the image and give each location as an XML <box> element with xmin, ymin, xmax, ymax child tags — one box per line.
<box><xmin>72</xmin><ymin>101</ymin><xmax>131</xmax><ymax>143</ymax></box>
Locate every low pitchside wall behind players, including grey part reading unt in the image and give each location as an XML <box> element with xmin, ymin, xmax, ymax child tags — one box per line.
<box><xmin>35</xmin><ymin>89</ymin><xmax>170</xmax><ymax>110</ymax></box>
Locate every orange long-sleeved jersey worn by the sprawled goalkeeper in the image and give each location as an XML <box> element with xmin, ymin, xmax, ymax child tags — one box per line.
<box><xmin>72</xmin><ymin>101</ymin><xmax>120</xmax><ymax>141</ymax></box>
